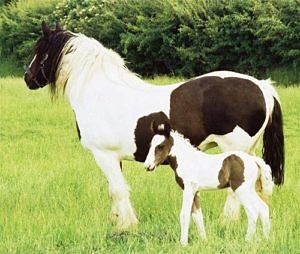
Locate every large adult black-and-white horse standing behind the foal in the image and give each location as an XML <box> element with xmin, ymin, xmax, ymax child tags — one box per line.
<box><xmin>24</xmin><ymin>22</ymin><xmax>284</xmax><ymax>230</ymax></box>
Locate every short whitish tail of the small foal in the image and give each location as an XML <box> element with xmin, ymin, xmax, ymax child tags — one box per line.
<box><xmin>255</xmin><ymin>157</ymin><xmax>274</xmax><ymax>199</ymax></box>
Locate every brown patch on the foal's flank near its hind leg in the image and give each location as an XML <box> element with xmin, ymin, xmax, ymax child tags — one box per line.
<box><xmin>218</xmin><ymin>154</ymin><xmax>245</xmax><ymax>191</ymax></box>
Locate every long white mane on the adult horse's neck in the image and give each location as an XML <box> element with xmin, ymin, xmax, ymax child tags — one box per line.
<box><xmin>56</xmin><ymin>34</ymin><xmax>145</xmax><ymax>91</ymax></box>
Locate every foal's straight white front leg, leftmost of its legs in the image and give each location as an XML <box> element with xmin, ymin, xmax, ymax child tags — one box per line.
<box><xmin>180</xmin><ymin>183</ymin><xmax>194</xmax><ymax>245</ymax></box>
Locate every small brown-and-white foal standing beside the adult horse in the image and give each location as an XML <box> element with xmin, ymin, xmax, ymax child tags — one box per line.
<box><xmin>144</xmin><ymin>123</ymin><xmax>274</xmax><ymax>245</ymax></box>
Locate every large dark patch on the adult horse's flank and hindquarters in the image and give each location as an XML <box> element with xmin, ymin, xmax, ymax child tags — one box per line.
<box><xmin>170</xmin><ymin>76</ymin><xmax>266</xmax><ymax>146</ymax></box>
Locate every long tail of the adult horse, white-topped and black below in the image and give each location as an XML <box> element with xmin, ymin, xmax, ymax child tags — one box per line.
<box><xmin>263</xmin><ymin>80</ymin><xmax>284</xmax><ymax>185</ymax></box>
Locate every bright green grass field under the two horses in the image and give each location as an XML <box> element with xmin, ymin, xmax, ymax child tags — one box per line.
<box><xmin>0</xmin><ymin>77</ymin><xmax>300</xmax><ymax>254</ymax></box>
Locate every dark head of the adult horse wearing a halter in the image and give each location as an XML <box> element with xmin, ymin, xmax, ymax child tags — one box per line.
<box><xmin>24</xmin><ymin>22</ymin><xmax>70</xmax><ymax>89</ymax></box>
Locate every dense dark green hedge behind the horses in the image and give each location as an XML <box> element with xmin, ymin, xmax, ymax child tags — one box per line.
<box><xmin>0</xmin><ymin>0</ymin><xmax>300</xmax><ymax>76</ymax></box>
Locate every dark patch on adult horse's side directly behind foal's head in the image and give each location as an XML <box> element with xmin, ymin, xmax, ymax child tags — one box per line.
<box><xmin>134</xmin><ymin>112</ymin><xmax>169</xmax><ymax>162</ymax></box>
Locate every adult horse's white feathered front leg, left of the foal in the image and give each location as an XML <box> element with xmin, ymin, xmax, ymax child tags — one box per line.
<box><xmin>92</xmin><ymin>150</ymin><xmax>138</xmax><ymax>231</ymax></box>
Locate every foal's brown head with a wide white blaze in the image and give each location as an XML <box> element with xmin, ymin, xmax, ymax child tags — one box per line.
<box><xmin>144</xmin><ymin>122</ymin><xmax>174</xmax><ymax>171</ymax></box>
